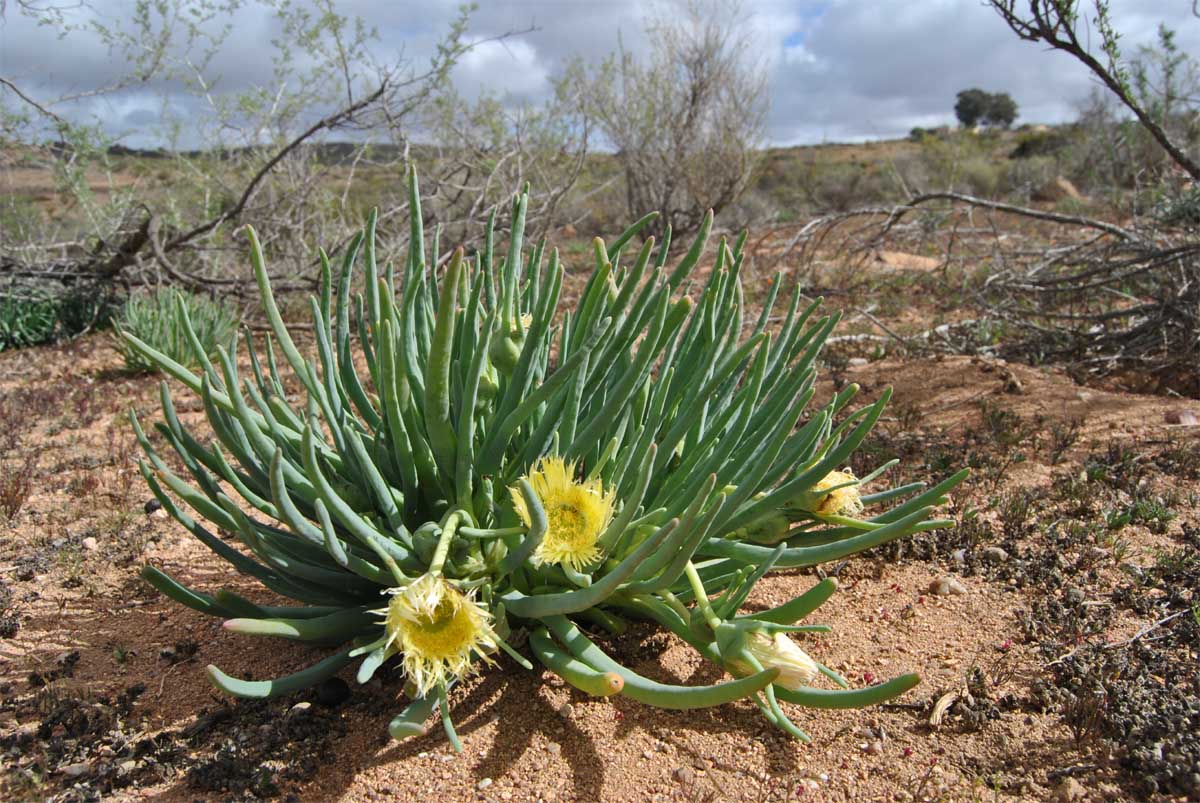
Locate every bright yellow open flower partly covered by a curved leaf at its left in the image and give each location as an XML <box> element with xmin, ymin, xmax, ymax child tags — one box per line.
<box><xmin>509</xmin><ymin>457</ymin><xmax>613</xmax><ymax>571</ymax></box>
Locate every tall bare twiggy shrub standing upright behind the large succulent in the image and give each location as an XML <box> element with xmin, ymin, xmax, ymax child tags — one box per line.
<box><xmin>565</xmin><ymin>0</ymin><xmax>767</xmax><ymax>234</ymax></box>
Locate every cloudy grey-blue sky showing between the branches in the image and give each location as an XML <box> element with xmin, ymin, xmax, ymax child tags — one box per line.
<box><xmin>0</xmin><ymin>0</ymin><xmax>1200</xmax><ymax>146</ymax></box>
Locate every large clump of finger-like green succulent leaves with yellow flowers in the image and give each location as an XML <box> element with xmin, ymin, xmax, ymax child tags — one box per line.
<box><xmin>124</xmin><ymin>174</ymin><xmax>965</xmax><ymax>748</ymax></box>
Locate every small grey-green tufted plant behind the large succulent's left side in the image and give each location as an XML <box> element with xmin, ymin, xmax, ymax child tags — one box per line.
<box><xmin>115</xmin><ymin>288</ymin><xmax>238</xmax><ymax>373</ymax></box>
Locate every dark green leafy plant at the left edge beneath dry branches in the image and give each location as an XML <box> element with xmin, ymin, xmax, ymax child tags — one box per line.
<box><xmin>0</xmin><ymin>286</ymin><xmax>113</xmax><ymax>352</ymax></box>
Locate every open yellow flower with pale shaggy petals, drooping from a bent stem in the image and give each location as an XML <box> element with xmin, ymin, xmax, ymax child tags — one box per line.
<box><xmin>376</xmin><ymin>574</ymin><xmax>498</xmax><ymax>696</ymax></box>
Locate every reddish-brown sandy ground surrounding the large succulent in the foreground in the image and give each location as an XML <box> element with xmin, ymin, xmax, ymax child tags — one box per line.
<box><xmin>0</xmin><ymin>260</ymin><xmax>1200</xmax><ymax>802</ymax></box>
